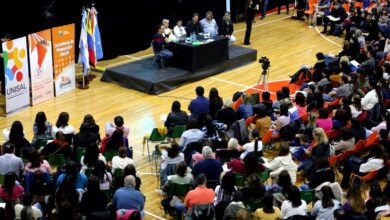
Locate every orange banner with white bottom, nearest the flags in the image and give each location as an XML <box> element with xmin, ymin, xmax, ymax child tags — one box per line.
<box><xmin>52</xmin><ymin>24</ymin><xmax>76</xmax><ymax>96</ymax></box>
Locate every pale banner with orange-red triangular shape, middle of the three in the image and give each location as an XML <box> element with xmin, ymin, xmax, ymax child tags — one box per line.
<box><xmin>28</xmin><ymin>29</ymin><xmax>54</xmax><ymax>105</ymax></box>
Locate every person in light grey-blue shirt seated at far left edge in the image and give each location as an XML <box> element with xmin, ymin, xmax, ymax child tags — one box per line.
<box><xmin>0</xmin><ymin>142</ymin><xmax>24</xmax><ymax>177</ymax></box>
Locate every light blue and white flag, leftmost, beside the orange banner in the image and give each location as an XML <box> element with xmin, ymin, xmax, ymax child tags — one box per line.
<box><xmin>78</xmin><ymin>10</ymin><xmax>89</xmax><ymax>76</ymax></box>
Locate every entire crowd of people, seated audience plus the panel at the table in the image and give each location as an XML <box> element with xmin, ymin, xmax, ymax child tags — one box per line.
<box><xmin>0</xmin><ymin>0</ymin><xmax>390</xmax><ymax>220</ymax></box>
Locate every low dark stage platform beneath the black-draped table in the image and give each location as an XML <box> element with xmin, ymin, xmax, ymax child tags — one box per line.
<box><xmin>101</xmin><ymin>45</ymin><xmax>257</xmax><ymax>95</ymax></box>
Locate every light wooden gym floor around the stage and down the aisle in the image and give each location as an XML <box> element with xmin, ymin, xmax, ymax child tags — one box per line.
<box><xmin>0</xmin><ymin>14</ymin><xmax>342</xmax><ymax>219</ymax></box>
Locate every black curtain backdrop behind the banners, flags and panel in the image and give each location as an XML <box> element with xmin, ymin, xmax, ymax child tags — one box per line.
<box><xmin>0</xmin><ymin>0</ymin><xmax>226</xmax><ymax>59</ymax></box>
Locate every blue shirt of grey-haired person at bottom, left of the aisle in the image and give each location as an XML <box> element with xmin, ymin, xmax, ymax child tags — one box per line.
<box><xmin>113</xmin><ymin>187</ymin><xmax>145</xmax><ymax>212</ymax></box>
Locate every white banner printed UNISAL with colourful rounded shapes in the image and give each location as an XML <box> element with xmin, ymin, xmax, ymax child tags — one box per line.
<box><xmin>2</xmin><ymin>37</ymin><xmax>30</xmax><ymax>115</ymax></box>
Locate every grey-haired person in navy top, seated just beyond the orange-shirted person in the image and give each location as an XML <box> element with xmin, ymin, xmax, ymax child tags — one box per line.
<box><xmin>192</xmin><ymin>146</ymin><xmax>223</xmax><ymax>189</ymax></box>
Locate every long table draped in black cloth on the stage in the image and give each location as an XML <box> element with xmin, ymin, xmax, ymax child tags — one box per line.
<box><xmin>169</xmin><ymin>36</ymin><xmax>229</xmax><ymax>72</ymax></box>
